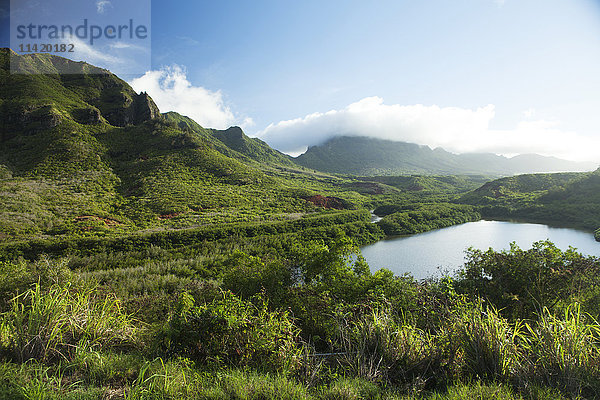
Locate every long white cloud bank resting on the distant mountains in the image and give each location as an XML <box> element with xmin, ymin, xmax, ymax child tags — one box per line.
<box><xmin>257</xmin><ymin>97</ymin><xmax>600</xmax><ymax>161</ymax></box>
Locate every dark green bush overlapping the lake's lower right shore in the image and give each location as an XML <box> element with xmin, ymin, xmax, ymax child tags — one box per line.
<box><xmin>458</xmin><ymin>241</ymin><xmax>600</xmax><ymax>318</ymax></box>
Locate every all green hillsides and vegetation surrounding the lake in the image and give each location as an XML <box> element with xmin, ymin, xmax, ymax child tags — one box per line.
<box><xmin>0</xmin><ymin>50</ymin><xmax>600</xmax><ymax>399</ymax></box>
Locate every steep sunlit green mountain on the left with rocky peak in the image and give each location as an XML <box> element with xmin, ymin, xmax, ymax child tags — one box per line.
<box><xmin>0</xmin><ymin>49</ymin><xmax>332</xmax><ymax>240</ymax></box>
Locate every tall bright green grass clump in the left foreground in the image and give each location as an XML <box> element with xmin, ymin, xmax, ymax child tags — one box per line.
<box><xmin>0</xmin><ymin>284</ymin><xmax>136</xmax><ymax>362</ymax></box>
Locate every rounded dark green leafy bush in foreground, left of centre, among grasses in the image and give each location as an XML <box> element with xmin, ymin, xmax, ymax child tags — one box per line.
<box><xmin>160</xmin><ymin>292</ymin><xmax>300</xmax><ymax>371</ymax></box>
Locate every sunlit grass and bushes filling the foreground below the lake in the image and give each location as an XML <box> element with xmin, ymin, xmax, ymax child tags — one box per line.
<box><xmin>0</xmin><ymin>236</ymin><xmax>600</xmax><ymax>399</ymax></box>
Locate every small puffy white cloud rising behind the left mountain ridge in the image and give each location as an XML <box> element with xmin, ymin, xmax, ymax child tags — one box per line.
<box><xmin>129</xmin><ymin>65</ymin><xmax>247</xmax><ymax>129</ymax></box>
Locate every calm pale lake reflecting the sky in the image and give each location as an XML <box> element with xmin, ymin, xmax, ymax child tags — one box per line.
<box><xmin>361</xmin><ymin>221</ymin><xmax>600</xmax><ymax>279</ymax></box>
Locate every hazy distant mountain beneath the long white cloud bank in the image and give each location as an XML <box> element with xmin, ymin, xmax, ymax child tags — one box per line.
<box><xmin>295</xmin><ymin>136</ymin><xmax>597</xmax><ymax>176</ymax></box>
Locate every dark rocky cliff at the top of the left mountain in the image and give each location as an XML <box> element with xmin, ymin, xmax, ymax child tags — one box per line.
<box><xmin>0</xmin><ymin>49</ymin><xmax>162</xmax><ymax>140</ymax></box>
